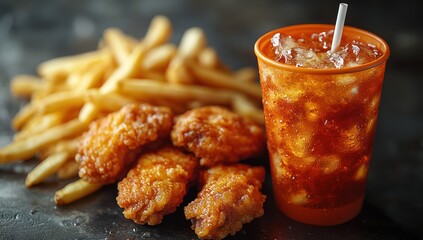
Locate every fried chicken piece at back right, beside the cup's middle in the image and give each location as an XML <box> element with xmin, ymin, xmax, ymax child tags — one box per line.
<box><xmin>171</xmin><ymin>106</ymin><xmax>265</xmax><ymax>167</ymax></box>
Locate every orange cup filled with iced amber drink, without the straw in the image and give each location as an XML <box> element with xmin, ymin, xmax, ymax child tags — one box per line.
<box><xmin>255</xmin><ymin>24</ymin><xmax>389</xmax><ymax>225</ymax></box>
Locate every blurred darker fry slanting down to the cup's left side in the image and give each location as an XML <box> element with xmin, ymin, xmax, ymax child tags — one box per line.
<box><xmin>187</xmin><ymin>61</ymin><xmax>261</xmax><ymax>101</ymax></box>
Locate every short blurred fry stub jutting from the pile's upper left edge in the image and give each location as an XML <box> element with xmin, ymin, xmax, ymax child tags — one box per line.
<box><xmin>10</xmin><ymin>75</ymin><xmax>44</xmax><ymax>98</ymax></box>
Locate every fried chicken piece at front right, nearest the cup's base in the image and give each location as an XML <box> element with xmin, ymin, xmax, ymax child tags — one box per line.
<box><xmin>184</xmin><ymin>164</ymin><xmax>266</xmax><ymax>239</ymax></box>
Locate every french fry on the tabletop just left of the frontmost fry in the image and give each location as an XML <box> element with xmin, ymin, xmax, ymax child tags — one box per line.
<box><xmin>25</xmin><ymin>152</ymin><xmax>69</xmax><ymax>188</ymax></box>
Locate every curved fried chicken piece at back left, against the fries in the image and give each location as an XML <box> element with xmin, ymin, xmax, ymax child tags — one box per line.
<box><xmin>75</xmin><ymin>104</ymin><xmax>173</xmax><ymax>184</ymax></box>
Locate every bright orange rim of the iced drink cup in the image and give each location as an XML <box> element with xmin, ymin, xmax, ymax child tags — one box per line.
<box><xmin>254</xmin><ymin>24</ymin><xmax>390</xmax><ymax>74</ymax></box>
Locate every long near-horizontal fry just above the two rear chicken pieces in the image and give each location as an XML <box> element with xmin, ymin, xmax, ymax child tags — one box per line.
<box><xmin>119</xmin><ymin>79</ymin><xmax>234</xmax><ymax>105</ymax></box>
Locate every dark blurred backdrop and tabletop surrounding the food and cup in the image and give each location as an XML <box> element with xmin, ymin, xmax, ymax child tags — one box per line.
<box><xmin>0</xmin><ymin>0</ymin><xmax>423</xmax><ymax>239</ymax></box>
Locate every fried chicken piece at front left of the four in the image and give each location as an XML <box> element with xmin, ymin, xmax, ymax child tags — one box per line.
<box><xmin>116</xmin><ymin>146</ymin><xmax>199</xmax><ymax>225</ymax></box>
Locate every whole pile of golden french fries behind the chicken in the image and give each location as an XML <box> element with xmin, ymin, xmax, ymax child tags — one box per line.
<box><xmin>0</xmin><ymin>16</ymin><xmax>264</xmax><ymax>205</ymax></box>
